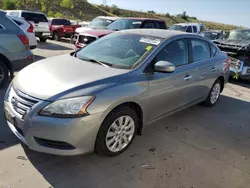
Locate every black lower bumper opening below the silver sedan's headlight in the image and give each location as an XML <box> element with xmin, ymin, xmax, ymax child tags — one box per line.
<box><xmin>34</xmin><ymin>137</ymin><xmax>75</xmax><ymax>150</ymax></box>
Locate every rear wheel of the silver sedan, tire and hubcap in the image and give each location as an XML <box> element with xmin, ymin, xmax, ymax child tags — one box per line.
<box><xmin>203</xmin><ymin>79</ymin><xmax>222</xmax><ymax>107</ymax></box>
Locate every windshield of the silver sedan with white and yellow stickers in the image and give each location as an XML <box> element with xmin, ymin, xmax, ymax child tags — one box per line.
<box><xmin>76</xmin><ymin>33</ymin><xmax>162</xmax><ymax>69</ymax></box>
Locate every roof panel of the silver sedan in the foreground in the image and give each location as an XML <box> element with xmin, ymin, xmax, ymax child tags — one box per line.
<box><xmin>117</xmin><ymin>29</ymin><xmax>190</xmax><ymax>39</ymax></box>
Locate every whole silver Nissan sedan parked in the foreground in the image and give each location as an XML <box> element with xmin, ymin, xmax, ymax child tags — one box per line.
<box><xmin>4</xmin><ymin>29</ymin><xmax>229</xmax><ymax>156</ymax></box>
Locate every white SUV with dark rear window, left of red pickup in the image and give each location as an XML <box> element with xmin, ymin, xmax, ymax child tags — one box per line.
<box><xmin>6</xmin><ymin>10</ymin><xmax>50</xmax><ymax>42</ymax></box>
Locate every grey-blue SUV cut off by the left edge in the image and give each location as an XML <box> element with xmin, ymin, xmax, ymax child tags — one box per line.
<box><xmin>0</xmin><ymin>10</ymin><xmax>33</xmax><ymax>88</ymax></box>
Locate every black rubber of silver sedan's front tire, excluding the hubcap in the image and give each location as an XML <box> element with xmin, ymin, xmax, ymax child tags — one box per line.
<box><xmin>95</xmin><ymin>106</ymin><xmax>139</xmax><ymax>157</ymax></box>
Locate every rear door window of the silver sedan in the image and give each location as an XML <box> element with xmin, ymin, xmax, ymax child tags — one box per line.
<box><xmin>191</xmin><ymin>40</ymin><xmax>210</xmax><ymax>62</ymax></box>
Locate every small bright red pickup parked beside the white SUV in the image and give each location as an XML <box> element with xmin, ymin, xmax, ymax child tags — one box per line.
<box><xmin>49</xmin><ymin>18</ymin><xmax>80</xmax><ymax>41</ymax></box>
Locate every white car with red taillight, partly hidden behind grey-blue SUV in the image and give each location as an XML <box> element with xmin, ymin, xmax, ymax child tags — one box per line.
<box><xmin>9</xmin><ymin>16</ymin><xmax>37</xmax><ymax>50</ymax></box>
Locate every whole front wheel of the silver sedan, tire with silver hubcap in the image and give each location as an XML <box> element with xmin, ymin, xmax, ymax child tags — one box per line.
<box><xmin>95</xmin><ymin>106</ymin><xmax>139</xmax><ymax>157</ymax></box>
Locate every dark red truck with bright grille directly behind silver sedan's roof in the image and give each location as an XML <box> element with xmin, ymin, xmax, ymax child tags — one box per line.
<box><xmin>75</xmin><ymin>18</ymin><xmax>168</xmax><ymax>49</ymax></box>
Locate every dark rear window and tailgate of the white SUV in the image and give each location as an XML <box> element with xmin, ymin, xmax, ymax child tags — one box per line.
<box><xmin>22</xmin><ymin>12</ymin><xmax>49</xmax><ymax>33</ymax></box>
